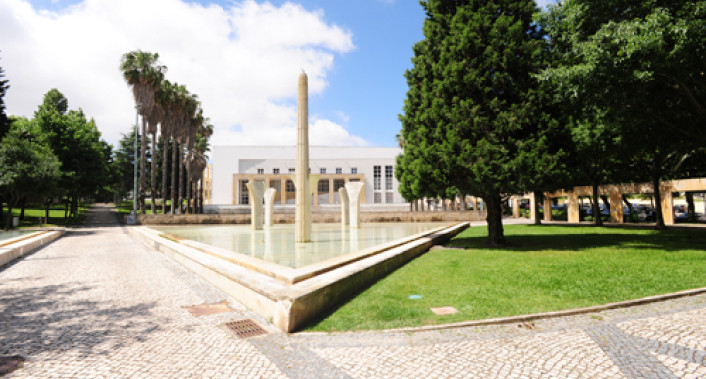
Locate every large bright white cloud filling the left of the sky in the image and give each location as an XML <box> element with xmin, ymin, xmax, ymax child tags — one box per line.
<box><xmin>0</xmin><ymin>0</ymin><xmax>365</xmax><ymax>145</ymax></box>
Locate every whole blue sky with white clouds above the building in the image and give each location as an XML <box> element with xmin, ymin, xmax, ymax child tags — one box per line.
<box><xmin>0</xmin><ymin>0</ymin><xmax>551</xmax><ymax>146</ymax></box>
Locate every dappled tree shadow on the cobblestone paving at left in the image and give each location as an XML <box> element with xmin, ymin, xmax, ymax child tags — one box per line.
<box><xmin>0</xmin><ymin>282</ymin><xmax>169</xmax><ymax>357</ymax></box>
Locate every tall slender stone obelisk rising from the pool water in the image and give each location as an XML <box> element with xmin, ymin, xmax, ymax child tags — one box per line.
<box><xmin>294</xmin><ymin>70</ymin><xmax>311</xmax><ymax>242</ymax></box>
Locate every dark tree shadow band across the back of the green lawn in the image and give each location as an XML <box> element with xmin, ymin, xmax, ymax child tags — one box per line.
<box><xmin>446</xmin><ymin>225</ymin><xmax>706</xmax><ymax>252</ymax></box>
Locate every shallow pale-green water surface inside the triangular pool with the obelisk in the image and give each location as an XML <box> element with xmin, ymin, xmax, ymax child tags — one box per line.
<box><xmin>152</xmin><ymin>223</ymin><xmax>449</xmax><ymax>268</ymax></box>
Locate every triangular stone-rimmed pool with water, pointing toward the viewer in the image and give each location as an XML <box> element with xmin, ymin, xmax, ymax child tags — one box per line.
<box><xmin>137</xmin><ymin>222</ymin><xmax>469</xmax><ymax>332</ymax></box>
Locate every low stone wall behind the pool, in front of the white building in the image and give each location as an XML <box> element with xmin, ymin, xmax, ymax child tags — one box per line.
<box><xmin>136</xmin><ymin>211</ymin><xmax>486</xmax><ymax>225</ymax></box>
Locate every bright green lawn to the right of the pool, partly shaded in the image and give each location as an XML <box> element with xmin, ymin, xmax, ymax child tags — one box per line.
<box><xmin>309</xmin><ymin>225</ymin><xmax>706</xmax><ymax>331</ymax></box>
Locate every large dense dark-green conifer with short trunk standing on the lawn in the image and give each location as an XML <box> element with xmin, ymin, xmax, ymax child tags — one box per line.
<box><xmin>399</xmin><ymin>0</ymin><xmax>560</xmax><ymax>245</ymax></box>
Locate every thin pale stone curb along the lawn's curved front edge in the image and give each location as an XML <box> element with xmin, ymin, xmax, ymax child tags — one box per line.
<box><xmin>371</xmin><ymin>287</ymin><xmax>706</xmax><ymax>333</ymax></box>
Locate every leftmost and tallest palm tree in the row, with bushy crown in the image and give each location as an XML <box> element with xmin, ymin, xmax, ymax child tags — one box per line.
<box><xmin>120</xmin><ymin>50</ymin><xmax>167</xmax><ymax>214</ymax></box>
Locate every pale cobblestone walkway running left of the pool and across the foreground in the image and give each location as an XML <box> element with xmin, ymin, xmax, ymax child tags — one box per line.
<box><xmin>0</xmin><ymin>206</ymin><xmax>706</xmax><ymax>378</ymax></box>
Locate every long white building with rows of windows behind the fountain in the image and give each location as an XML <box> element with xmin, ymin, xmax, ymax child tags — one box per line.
<box><xmin>209</xmin><ymin>146</ymin><xmax>405</xmax><ymax>205</ymax></box>
